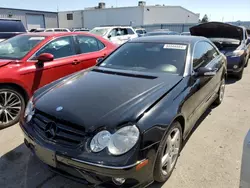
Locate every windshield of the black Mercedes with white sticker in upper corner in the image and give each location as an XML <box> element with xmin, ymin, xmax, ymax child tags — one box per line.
<box><xmin>100</xmin><ymin>42</ymin><xmax>187</xmax><ymax>75</ymax></box>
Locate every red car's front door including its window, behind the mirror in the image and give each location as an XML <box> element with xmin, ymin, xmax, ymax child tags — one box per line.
<box><xmin>23</xmin><ymin>36</ymin><xmax>78</xmax><ymax>92</ymax></box>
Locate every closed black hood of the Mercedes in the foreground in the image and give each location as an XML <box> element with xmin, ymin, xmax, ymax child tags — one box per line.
<box><xmin>34</xmin><ymin>68</ymin><xmax>182</xmax><ymax>132</ymax></box>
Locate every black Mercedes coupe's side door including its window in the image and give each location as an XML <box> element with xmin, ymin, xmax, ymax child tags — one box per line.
<box><xmin>183</xmin><ymin>41</ymin><xmax>219</xmax><ymax>130</ymax></box>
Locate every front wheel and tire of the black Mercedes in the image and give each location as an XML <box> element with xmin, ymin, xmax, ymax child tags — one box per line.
<box><xmin>154</xmin><ymin>122</ymin><xmax>182</xmax><ymax>183</ymax></box>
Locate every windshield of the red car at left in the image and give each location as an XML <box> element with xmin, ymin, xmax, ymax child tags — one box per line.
<box><xmin>0</xmin><ymin>35</ymin><xmax>45</xmax><ymax>59</ymax></box>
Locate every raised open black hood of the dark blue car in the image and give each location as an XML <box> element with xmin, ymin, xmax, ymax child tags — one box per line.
<box><xmin>190</xmin><ymin>22</ymin><xmax>243</xmax><ymax>40</ymax></box>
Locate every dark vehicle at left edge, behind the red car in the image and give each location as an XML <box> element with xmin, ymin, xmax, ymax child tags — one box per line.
<box><xmin>0</xmin><ymin>18</ymin><xmax>26</xmax><ymax>42</ymax></box>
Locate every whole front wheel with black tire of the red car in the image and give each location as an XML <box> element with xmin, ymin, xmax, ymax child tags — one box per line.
<box><xmin>0</xmin><ymin>87</ymin><xmax>25</xmax><ymax>130</ymax></box>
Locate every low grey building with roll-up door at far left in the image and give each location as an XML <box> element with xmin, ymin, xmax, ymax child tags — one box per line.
<box><xmin>0</xmin><ymin>7</ymin><xmax>58</xmax><ymax>30</ymax></box>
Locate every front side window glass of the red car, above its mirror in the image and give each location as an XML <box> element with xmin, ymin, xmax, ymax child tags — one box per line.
<box><xmin>32</xmin><ymin>37</ymin><xmax>76</xmax><ymax>60</ymax></box>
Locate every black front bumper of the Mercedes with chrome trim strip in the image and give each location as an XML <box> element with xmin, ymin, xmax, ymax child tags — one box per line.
<box><xmin>21</xmin><ymin>125</ymin><xmax>154</xmax><ymax>188</ymax></box>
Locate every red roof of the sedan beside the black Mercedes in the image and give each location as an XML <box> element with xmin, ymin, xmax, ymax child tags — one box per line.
<box><xmin>22</xmin><ymin>32</ymin><xmax>98</xmax><ymax>38</ymax></box>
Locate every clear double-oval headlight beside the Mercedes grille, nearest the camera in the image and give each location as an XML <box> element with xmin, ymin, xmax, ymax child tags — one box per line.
<box><xmin>90</xmin><ymin>125</ymin><xmax>140</xmax><ymax>155</ymax></box>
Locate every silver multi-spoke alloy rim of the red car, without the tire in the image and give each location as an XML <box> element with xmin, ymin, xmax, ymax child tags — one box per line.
<box><xmin>0</xmin><ymin>91</ymin><xmax>22</xmax><ymax>126</ymax></box>
